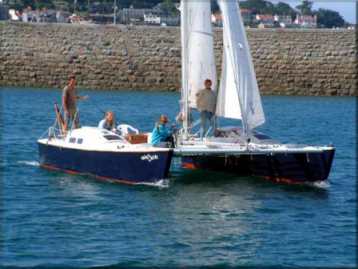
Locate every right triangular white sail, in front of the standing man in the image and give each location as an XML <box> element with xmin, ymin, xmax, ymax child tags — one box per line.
<box><xmin>217</xmin><ymin>0</ymin><xmax>265</xmax><ymax>129</ymax></box>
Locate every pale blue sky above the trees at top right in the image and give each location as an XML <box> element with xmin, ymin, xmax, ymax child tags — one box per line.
<box><xmin>271</xmin><ymin>0</ymin><xmax>358</xmax><ymax>23</ymax></box>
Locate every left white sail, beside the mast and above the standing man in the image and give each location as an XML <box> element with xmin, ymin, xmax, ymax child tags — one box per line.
<box><xmin>182</xmin><ymin>0</ymin><xmax>217</xmax><ymax>108</ymax></box>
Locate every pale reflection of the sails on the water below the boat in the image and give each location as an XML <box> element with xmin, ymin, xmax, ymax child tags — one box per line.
<box><xmin>171</xmin><ymin>171</ymin><xmax>261</xmax><ymax>264</ymax></box>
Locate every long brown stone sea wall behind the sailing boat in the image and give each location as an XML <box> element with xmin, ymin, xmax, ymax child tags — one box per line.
<box><xmin>0</xmin><ymin>22</ymin><xmax>357</xmax><ymax>95</ymax></box>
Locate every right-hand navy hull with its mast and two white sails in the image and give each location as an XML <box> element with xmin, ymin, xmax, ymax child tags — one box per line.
<box><xmin>174</xmin><ymin>0</ymin><xmax>335</xmax><ymax>183</ymax></box>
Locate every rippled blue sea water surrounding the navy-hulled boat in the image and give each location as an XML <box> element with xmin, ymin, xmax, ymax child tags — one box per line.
<box><xmin>0</xmin><ymin>88</ymin><xmax>357</xmax><ymax>267</ymax></box>
